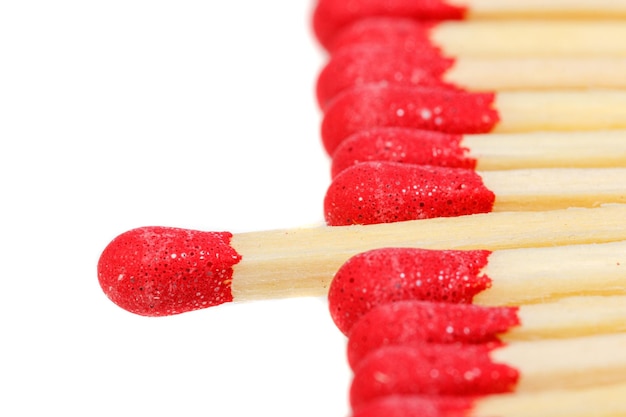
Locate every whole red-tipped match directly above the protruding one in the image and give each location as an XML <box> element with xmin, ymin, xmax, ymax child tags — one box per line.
<box><xmin>324</xmin><ymin>162</ymin><xmax>626</xmax><ymax>226</ymax></box>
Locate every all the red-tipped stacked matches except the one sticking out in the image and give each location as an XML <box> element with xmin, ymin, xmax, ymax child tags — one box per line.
<box><xmin>314</xmin><ymin>0</ymin><xmax>626</xmax><ymax>417</ymax></box>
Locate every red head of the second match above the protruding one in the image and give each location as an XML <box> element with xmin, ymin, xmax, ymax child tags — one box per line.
<box><xmin>331</xmin><ymin>127</ymin><xmax>470</xmax><ymax>178</ymax></box>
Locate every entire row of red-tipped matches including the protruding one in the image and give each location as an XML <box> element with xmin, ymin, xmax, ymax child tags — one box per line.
<box><xmin>98</xmin><ymin>0</ymin><xmax>626</xmax><ymax>417</ymax></box>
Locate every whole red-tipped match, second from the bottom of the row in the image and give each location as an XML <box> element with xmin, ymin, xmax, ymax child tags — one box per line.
<box><xmin>350</xmin><ymin>333</ymin><xmax>626</xmax><ymax>407</ymax></box>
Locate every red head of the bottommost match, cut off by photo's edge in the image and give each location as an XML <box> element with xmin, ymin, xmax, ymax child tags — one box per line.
<box><xmin>352</xmin><ymin>395</ymin><xmax>475</xmax><ymax>417</ymax></box>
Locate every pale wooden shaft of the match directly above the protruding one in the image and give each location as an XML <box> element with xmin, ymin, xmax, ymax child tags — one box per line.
<box><xmin>478</xmin><ymin>168</ymin><xmax>626</xmax><ymax>211</ymax></box>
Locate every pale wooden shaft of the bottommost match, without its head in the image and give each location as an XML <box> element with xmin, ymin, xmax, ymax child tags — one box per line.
<box><xmin>468</xmin><ymin>383</ymin><xmax>626</xmax><ymax>417</ymax></box>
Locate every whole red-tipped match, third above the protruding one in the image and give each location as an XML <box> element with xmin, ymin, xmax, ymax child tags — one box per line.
<box><xmin>321</xmin><ymin>84</ymin><xmax>626</xmax><ymax>155</ymax></box>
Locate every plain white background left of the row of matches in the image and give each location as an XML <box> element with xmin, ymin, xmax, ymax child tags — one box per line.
<box><xmin>0</xmin><ymin>0</ymin><xmax>349</xmax><ymax>417</ymax></box>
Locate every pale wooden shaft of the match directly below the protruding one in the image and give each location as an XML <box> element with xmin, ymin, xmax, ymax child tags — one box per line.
<box><xmin>474</xmin><ymin>239</ymin><xmax>626</xmax><ymax>305</ymax></box>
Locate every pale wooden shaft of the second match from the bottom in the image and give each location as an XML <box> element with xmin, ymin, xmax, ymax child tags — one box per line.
<box><xmin>491</xmin><ymin>333</ymin><xmax>626</xmax><ymax>392</ymax></box>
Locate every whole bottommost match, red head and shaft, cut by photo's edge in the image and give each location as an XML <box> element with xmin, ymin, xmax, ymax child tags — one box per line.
<box><xmin>351</xmin><ymin>383</ymin><xmax>626</xmax><ymax>417</ymax></box>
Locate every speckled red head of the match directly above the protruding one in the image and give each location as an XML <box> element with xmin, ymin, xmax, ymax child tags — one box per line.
<box><xmin>324</xmin><ymin>162</ymin><xmax>495</xmax><ymax>226</ymax></box>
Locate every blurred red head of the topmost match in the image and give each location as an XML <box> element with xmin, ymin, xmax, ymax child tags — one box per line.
<box><xmin>313</xmin><ymin>0</ymin><xmax>467</xmax><ymax>48</ymax></box>
